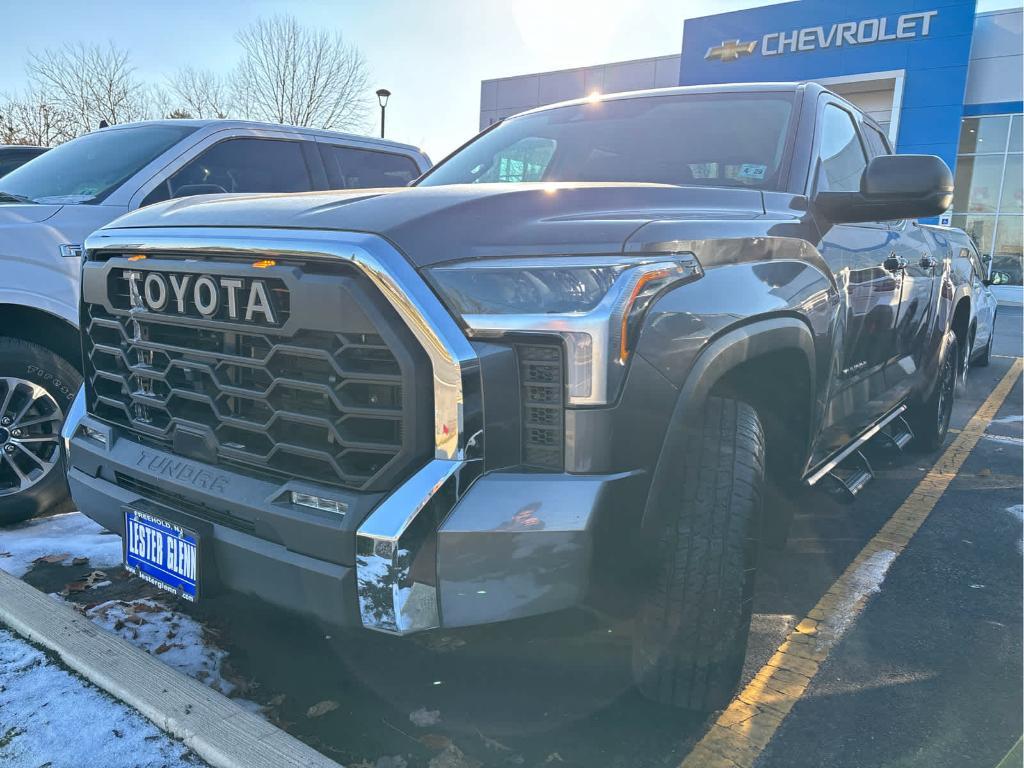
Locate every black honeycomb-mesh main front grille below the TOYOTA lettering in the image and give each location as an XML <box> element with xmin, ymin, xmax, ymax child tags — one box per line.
<box><xmin>82</xmin><ymin>259</ymin><xmax>429</xmax><ymax>490</ymax></box>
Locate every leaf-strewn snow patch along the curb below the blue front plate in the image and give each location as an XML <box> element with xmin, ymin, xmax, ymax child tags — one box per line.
<box><xmin>85</xmin><ymin>599</ymin><xmax>242</xmax><ymax>703</ymax></box>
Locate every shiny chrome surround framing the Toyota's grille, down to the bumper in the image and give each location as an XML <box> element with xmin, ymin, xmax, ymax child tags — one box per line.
<box><xmin>85</xmin><ymin>227</ymin><xmax>483</xmax><ymax>634</ymax></box>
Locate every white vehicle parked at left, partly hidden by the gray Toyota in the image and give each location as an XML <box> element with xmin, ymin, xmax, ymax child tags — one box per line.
<box><xmin>0</xmin><ymin>120</ymin><xmax>430</xmax><ymax>524</ymax></box>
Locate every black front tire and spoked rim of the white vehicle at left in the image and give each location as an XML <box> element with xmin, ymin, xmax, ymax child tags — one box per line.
<box><xmin>0</xmin><ymin>336</ymin><xmax>82</xmax><ymax>525</ymax></box>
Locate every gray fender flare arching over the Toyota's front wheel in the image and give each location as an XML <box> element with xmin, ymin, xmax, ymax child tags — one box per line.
<box><xmin>640</xmin><ymin>316</ymin><xmax>816</xmax><ymax>550</ymax></box>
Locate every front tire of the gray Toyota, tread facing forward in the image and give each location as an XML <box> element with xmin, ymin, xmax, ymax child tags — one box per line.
<box><xmin>633</xmin><ymin>397</ymin><xmax>765</xmax><ymax>712</ymax></box>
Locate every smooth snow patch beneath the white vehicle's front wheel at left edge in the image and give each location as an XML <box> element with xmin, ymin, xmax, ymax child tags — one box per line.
<box><xmin>0</xmin><ymin>512</ymin><xmax>122</xmax><ymax>578</ymax></box>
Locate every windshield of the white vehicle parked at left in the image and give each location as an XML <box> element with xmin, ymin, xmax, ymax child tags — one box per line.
<box><xmin>0</xmin><ymin>125</ymin><xmax>196</xmax><ymax>204</ymax></box>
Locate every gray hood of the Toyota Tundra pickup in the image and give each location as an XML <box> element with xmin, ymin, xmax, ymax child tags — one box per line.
<box><xmin>99</xmin><ymin>183</ymin><xmax>764</xmax><ymax>266</ymax></box>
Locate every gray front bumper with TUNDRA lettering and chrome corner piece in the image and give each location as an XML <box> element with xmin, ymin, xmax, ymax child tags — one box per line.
<box><xmin>69</xmin><ymin>417</ymin><xmax>643</xmax><ymax>634</ymax></box>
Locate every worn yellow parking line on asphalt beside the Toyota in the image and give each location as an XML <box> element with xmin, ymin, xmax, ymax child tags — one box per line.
<box><xmin>680</xmin><ymin>357</ymin><xmax>1022</xmax><ymax>768</ymax></box>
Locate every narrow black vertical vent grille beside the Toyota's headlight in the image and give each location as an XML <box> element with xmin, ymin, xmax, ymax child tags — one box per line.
<box><xmin>516</xmin><ymin>344</ymin><xmax>565</xmax><ymax>469</ymax></box>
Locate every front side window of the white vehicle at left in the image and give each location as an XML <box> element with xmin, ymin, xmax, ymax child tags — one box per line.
<box><xmin>142</xmin><ymin>138</ymin><xmax>312</xmax><ymax>206</ymax></box>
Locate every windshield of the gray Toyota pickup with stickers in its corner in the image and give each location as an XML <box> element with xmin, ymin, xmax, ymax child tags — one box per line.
<box><xmin>420</xmin><ymin>92</ymin><xmax>793</xmax><ymax>189</ymax></box>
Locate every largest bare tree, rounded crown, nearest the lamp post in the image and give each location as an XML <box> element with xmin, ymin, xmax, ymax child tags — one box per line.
<box><xmin>232</xmin><ymin>15</ymin><xmax>368</xmax><ymax>130</ymax></box>
